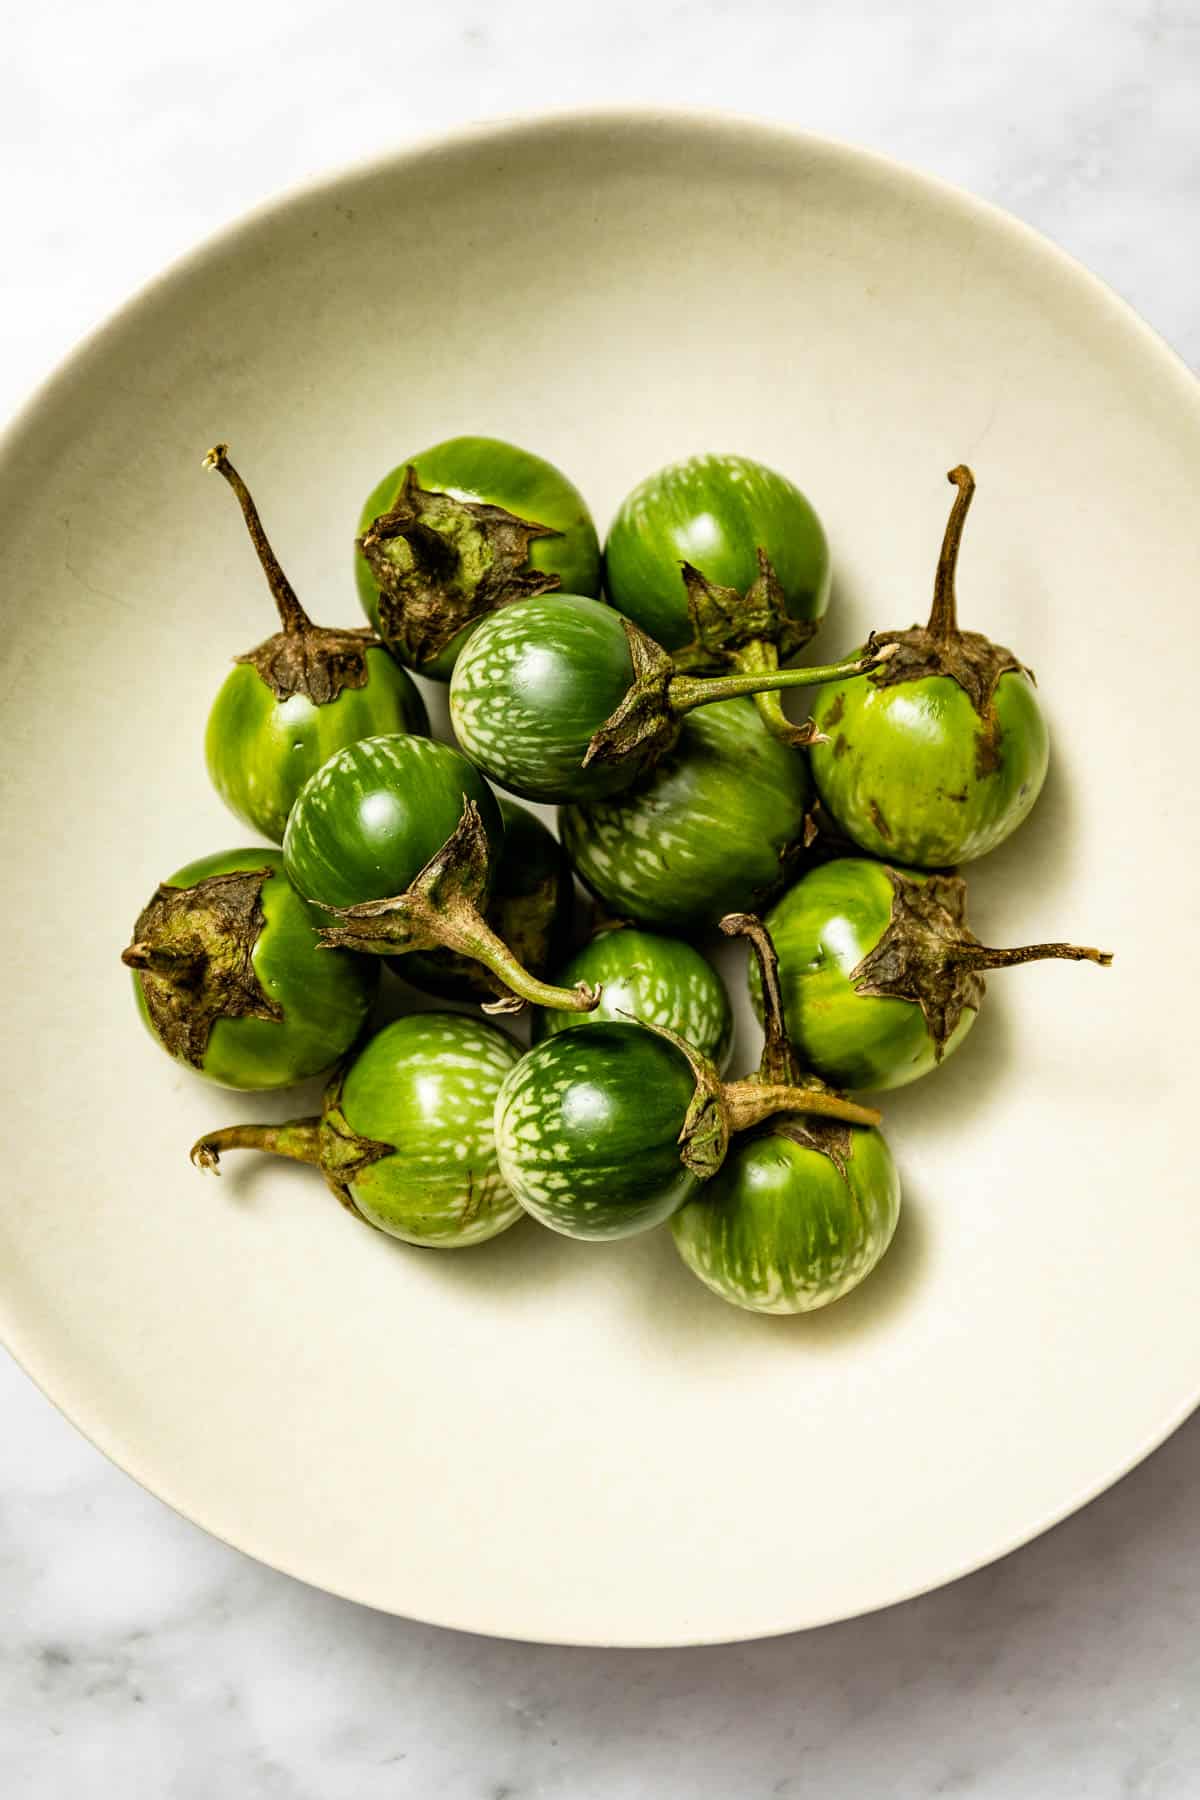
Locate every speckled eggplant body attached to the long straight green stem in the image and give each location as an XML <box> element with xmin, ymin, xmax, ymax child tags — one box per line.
<box><xmin>450</xmin><ymin>594</ymin><xmax>639</xmax><ymax>801</ymax></box>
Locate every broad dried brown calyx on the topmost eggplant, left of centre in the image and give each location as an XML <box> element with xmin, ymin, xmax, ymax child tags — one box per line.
<box><xmin>356</xmin><ymin>463</ymin><xmax>560</xmax><ymax>666</ymax></box>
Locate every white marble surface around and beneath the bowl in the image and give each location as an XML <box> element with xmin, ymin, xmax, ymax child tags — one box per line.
<box><xmin>0</xmin><ymin>0</ymin><xmax>1200</xmax><ymax>1800</ymax></box>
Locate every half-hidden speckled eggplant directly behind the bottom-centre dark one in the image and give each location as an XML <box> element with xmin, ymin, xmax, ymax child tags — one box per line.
<box><xmin>533</xmin><ymin>925</ymin><xmax>734</xmax><ymax>1069</ymax></box>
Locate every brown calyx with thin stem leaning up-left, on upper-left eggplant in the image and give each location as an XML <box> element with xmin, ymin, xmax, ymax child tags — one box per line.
<box><xmin>203</xmin><ymin>445</ymin><xmax>381</xmax><ymax>706</ymax></box>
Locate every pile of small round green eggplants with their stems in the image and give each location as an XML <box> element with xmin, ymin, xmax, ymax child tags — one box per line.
<box><xmin>122</xmin><ymin>437</ymin><xmax>1112</xmax><ymax>1314</ymax></box>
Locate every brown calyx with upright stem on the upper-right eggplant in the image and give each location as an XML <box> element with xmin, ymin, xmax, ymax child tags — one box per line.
<box><xmin>871</xmin><ymin>464</ymin><xmax>1033</xmax><ymax>727</ymax></box>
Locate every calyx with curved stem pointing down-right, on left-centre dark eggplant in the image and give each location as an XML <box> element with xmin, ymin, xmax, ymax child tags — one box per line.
<box><xmin>305</xmin><ymin>797</ymin><xmax>599</xmax><ymax>1013</ymax></box>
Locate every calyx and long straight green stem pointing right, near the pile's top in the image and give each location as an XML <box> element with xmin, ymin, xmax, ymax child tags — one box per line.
<box><xmin>583</xmin><ymin>619</ymin><xmax>894</xmax><ymax>769</ymax></box>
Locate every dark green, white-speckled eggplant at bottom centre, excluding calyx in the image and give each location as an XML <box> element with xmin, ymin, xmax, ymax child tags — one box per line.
<box><xmin>495</xmin><ymin>1024</ymin><xmax>698</xmax><ymax>1238</ymax></box>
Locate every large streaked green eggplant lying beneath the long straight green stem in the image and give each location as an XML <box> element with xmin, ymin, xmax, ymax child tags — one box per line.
<box><xmin>560</xmin><ymin>698</ymin><xmax>811</xmax><ymax>932</ymax></box>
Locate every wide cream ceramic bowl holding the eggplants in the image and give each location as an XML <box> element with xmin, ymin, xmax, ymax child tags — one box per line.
<box><xmin>0</xmin><ymin>113</ymin><xmax>1200</xmax><ymax>1643</ymax></box>
